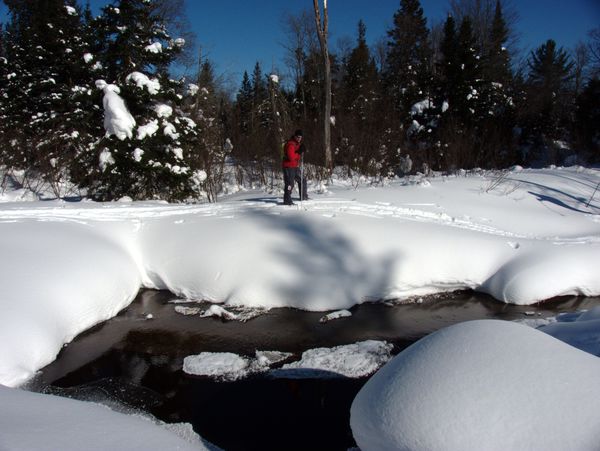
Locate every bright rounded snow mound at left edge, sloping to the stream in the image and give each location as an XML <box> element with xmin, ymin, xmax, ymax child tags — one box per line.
<box><xmin>0</xmin><ymin>220</ymin><xmax>141</xmax><ymax>386</ymax></box>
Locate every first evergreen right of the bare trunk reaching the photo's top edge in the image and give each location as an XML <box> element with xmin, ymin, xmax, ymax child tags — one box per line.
<box><xmin>384</xmin><ymin>0</ymin><xmax>432</xmax><ymax>114</ymax></box>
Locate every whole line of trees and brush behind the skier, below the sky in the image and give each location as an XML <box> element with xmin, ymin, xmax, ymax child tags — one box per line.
<box><xmin>0</xmin><ymin>0</ymin><xmax>600</xmax><ymax>201</ymax></box>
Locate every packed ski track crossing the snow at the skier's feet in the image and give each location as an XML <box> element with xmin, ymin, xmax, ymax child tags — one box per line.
<box><xmin>0</xmin><ymin>199</ymin><xmax>600</xmax><ymax>245</ymax></box>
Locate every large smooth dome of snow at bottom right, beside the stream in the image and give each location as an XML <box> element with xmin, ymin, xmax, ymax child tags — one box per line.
<box><xmin>350</xmin><ymin>320</ymin><xmax>600</xmax><ymax>451</ymax></box>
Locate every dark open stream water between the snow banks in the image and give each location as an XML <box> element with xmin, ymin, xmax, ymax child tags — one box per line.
<box><xmin>31</xmin><ymin>290</ymin><xmax>600</xmax><ymax>450</ymax></box>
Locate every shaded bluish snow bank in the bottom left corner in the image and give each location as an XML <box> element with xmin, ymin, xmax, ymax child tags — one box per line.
<box><xmin>0</xmin><ymin>385</ymin><xmax>214</xmax><ymax>451</ymax></box>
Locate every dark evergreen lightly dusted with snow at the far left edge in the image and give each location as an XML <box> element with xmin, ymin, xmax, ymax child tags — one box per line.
<box><xmin>3</xmin><ymin>0</ymin><xmax>90</xmax><ymax>196</ymax></box>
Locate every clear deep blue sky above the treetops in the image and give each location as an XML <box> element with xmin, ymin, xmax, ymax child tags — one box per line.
<box><xmin>0</xmin><ymin>0</ymin><xmax>600</xmax><ymax>85</ymax></box>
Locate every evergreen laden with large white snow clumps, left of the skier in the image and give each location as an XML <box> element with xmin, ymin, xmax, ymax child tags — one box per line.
<box><xmin>80</xmin><ymin>0</ymin><xmax>199</xmax><ymax>200</ymax></box>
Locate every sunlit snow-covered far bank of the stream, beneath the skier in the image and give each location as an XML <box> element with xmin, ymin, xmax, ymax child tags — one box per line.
<box><xmin>0</xmin><ymin>167</ymin><xmax>600</xmax><ymax>450</ymax></box>
